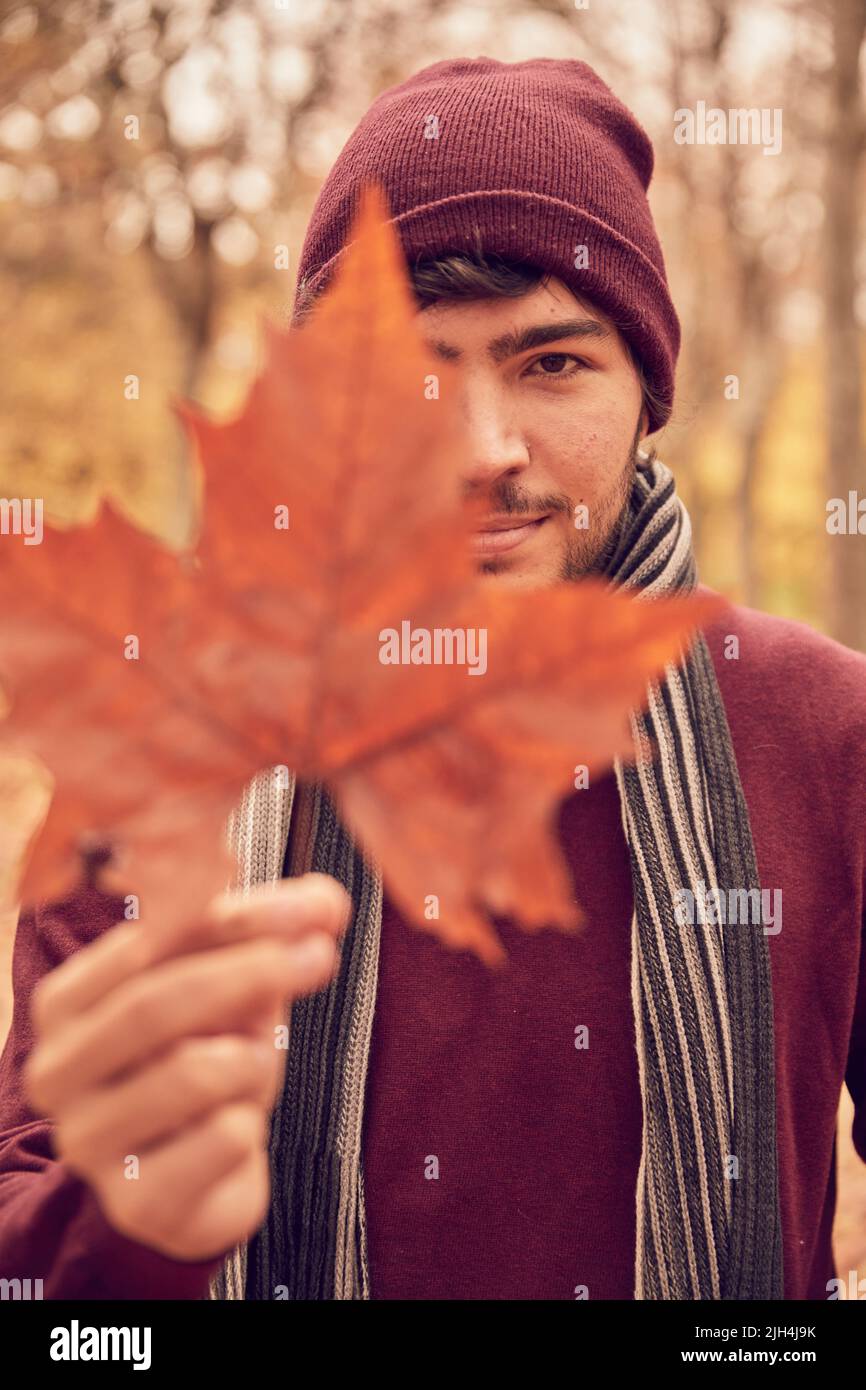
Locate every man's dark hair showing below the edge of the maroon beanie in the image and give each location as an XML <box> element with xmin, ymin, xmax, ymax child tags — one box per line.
<box><xmin>409</xmin><ymin>250</ymin><xmax>666</xmax><ymax>420</ymax></box>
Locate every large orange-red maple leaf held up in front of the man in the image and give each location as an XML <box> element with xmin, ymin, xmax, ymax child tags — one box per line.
<box><xmin>0</xmin><ymin>189</ymin><xmax>720</xmax><ymax>963</ymax></box>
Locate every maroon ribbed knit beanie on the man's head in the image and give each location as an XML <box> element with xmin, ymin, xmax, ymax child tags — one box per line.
<box><xmin>295</xmin><ymin>58</ymin><xmax>680</xmax><ymax>430</ymax></box>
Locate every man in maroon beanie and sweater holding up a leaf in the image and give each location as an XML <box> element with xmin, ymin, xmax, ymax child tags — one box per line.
<box><xmin>0</xmin><ymin>58</ymin><xmax>866</xmax><ymax>1300</ymax></box>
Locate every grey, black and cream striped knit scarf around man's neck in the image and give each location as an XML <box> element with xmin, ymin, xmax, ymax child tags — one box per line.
<box><xmin>210</xmin><ymin>455</ymin><xmax>784</xmax><ymax>1300</ymax></box>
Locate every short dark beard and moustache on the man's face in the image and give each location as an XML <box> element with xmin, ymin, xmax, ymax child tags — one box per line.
<box><xmin>467</xmin><ymin>420</ymin><xmax>642</xmax><ymax>581</ymax></box>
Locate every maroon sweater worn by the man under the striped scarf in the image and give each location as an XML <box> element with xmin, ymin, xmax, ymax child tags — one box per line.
<box><xmin>0</xmin><ymin>592</ymin><xmax>866</xmax><ymax>1300</ymax></box>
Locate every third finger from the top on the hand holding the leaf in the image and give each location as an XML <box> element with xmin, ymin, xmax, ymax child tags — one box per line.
<box><xmin>54</xmin><ymin>1034</ymin><xmax>277</xmax><ymax>1166</ymax></box>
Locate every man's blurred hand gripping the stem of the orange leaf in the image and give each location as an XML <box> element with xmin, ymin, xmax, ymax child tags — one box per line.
<box><xmin>24</xmin><ymin>873</ymin><xmax>352</xmax><ymax>1261</ymax></box>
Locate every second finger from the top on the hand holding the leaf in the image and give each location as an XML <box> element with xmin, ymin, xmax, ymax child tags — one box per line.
<box><xmin>25</xmin><ymin>933</ymin><xmax>338</xmax><ymax>1113</ymax></box>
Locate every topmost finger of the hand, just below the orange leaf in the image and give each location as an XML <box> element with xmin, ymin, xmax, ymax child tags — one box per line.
<box><xmin>31</xmin><ymin>874</ymin><xmax>352</xmax><ymax>1037</ymax></box>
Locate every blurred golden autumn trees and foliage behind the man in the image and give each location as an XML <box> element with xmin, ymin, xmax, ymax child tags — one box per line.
<box><xmin>0</xmin><ymin>0</ymin><xmax>866</xmax><ymax>1273</ymax></box>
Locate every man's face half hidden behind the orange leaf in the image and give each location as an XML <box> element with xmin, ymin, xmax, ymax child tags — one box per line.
<box><xmin>418</xmin><ymin>279</ymin><xmax>646</xmax><ymax>588</ymax></box>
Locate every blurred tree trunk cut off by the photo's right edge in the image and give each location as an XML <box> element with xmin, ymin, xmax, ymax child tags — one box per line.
<box><xmin>824</xmin><ymin>0</ymin><xmax>866</xmax><ymax>651</ymax></box>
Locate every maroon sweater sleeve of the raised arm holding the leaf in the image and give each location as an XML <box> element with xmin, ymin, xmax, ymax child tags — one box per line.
<box><xmin>0</xmin><ymin>888</ymin><xmax>228</xmax><ymax>1300</ymax></box>
